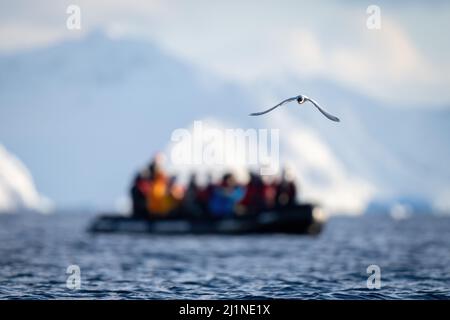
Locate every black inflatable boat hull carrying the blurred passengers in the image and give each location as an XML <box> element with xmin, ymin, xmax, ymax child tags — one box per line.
<box><xmin>89</xmin><ymin>204</ymin><xmax>326</xmax><ymax>235</ymax></box>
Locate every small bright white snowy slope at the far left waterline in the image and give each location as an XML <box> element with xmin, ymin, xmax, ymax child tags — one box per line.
<box><xmin>0</xmin><ymin>145</ymin><xmax>50</xmax><ymax>213</ymax></box>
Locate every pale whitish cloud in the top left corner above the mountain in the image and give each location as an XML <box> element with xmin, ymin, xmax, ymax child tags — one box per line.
<box><xmin>0</xmin><ymin>0</ymin><xmax>164</xmax><ymax>51</ymax></box>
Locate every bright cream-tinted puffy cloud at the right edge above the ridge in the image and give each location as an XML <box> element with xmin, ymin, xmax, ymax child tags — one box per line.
<box><xmin>322</xmin><ymin>18</ymin><xmax>450</xmax><ymax>106</ymax></box>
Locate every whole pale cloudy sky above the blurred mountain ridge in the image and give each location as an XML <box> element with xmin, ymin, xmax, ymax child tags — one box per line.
<box><xmin>0</xmin><ymin>0</ymin><xmax>450</xmax><ymax>108</ymax></box>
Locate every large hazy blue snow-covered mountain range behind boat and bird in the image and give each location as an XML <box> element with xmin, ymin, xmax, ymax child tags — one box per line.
<box><xmin>0</xmin><ymin>33</ymin><xmax>450</xmax><ymax>212</ymax></box>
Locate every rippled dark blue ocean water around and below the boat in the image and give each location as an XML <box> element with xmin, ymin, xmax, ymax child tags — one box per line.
<box><xmin>0</xmin><ymin>214</ymin><xmax>450</xmax><ymax>299</ymax></box>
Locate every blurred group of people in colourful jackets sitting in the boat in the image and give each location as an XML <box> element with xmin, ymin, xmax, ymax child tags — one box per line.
<box><xmin>131</xmin><ymin>155</ymin><xmax>298</xmax><ymax>218</ymax></box>
